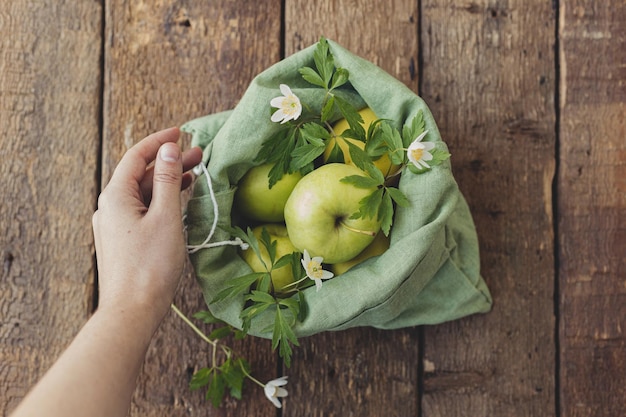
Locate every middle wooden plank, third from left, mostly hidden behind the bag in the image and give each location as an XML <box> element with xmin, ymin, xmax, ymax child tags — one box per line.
<box><xmin>283</xmin><ymin>0</ymin><xmax>419</xmax><ymax>417</ymax></box>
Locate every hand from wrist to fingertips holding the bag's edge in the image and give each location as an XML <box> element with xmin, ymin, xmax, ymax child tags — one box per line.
<box><xmin>93</xmin><ymin>128</ymin><xmax>202</xmax><ymax>327</ymax></box>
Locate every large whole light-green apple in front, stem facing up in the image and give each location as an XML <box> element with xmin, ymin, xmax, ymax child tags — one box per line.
<box><xmin>285</xmin><ymin>163</ymin><xmax>380</xmax><ymax>264</ymax></box>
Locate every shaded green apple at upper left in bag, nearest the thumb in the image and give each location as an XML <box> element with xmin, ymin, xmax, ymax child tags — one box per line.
<box><xmin>234</xmin><ymin>164</ymin><xmax>302</xmax><ymax>222</ymax></box>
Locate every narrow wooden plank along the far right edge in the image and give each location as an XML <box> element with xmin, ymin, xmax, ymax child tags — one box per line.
<box><xmin>558</xmin><ymin>0</ymin><xmax>626</xmax><ymax>417</ymax></box>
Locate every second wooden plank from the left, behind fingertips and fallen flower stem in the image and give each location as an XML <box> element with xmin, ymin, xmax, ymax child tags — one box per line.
<box><xmin>103</xmin><ymin>0</ymin><xmax>281</xmax><ymax>416</ymax></box>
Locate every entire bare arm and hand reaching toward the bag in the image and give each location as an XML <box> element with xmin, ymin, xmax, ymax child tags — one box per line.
<box><xmin>12</xmin><ymin>128</ymin><xmax>202</xmax><ymax>417</ymax></box>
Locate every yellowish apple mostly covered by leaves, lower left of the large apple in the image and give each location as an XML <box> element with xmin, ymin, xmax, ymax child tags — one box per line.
<box><xmin>240</xmin><ymin>224</ymin><xmax>298</xmax><ymax>293</ymax></box>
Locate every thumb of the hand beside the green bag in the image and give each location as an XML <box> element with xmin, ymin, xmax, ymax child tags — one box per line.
<box><xmin>150</xmin><ymin>142</ymin><xmax>183</xmax><ymax>216</ymax></box>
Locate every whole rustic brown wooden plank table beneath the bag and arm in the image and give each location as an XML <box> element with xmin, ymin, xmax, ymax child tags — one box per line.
<box><xmin>0</xmin><ymin>0</ymin><xmax>626</xmax><ymax>417</ymax></box>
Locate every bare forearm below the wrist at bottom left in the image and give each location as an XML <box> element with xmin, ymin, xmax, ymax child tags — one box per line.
<box><xmin>13</xmin><ymin>309</ymin><xmax>158</xmax><ymax>417</ymax></box>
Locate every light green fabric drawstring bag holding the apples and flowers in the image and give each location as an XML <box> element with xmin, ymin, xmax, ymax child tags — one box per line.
<box><xmin>182</xmin><ymin>40</ymin><xmax>492</xmax><ymax>338</ymax></box>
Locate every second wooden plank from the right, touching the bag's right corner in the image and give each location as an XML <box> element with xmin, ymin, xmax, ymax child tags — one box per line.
<box><xmin>422</xmin><ymin>0</ymin><xmax>556</xmax><ymax>417</ymax></box>
